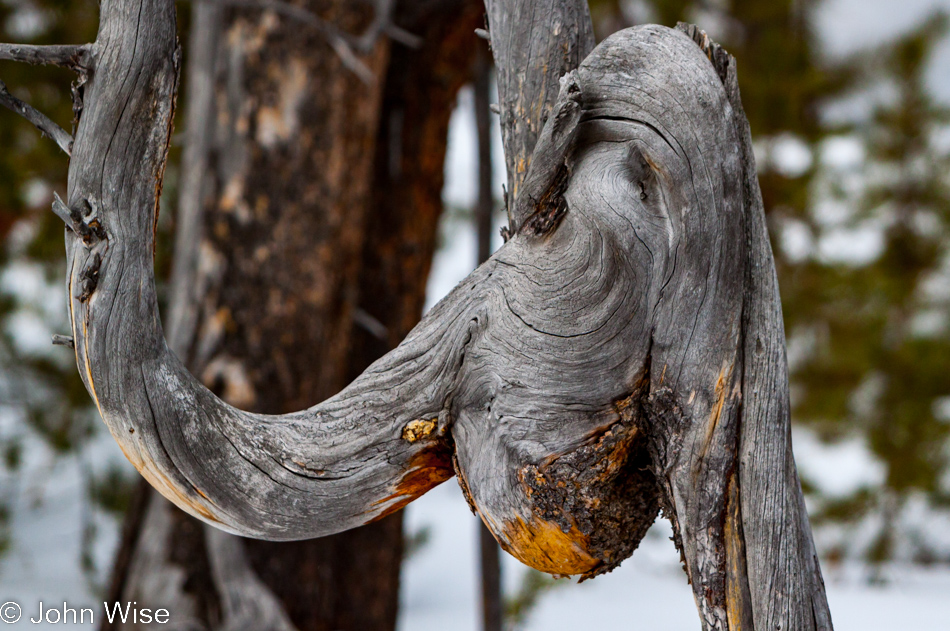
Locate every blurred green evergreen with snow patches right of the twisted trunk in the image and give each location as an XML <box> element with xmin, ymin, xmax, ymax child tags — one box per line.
<box><xmin>786</xmin><ymin>15</ymin><xmax>950</xmax><ymax>563</ymax></box>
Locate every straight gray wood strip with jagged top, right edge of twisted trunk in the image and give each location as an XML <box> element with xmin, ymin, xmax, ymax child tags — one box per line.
<box><xmin>678</xmin><ymin>24</ymin><xmax>832</xmax><ymax>629</ymax></box>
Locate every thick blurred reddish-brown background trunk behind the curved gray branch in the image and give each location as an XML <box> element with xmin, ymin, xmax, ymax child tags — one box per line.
<box><xmin>104</xmin><ymin>0</ymin><xmax>482</xmax><ymax>630</ymax></box>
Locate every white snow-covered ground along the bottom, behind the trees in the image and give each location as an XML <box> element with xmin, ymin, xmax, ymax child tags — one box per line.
<box><xmin>0</xmin><ymin>445</ymin><xmax>950</xmax><ymax>631</ymax></box>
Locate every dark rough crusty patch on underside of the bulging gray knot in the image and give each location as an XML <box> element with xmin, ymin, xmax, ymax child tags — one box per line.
<box><xmin>518</xmin><ymin>404</ymin><xmax>659</xmax><ymax>580</ymax></box>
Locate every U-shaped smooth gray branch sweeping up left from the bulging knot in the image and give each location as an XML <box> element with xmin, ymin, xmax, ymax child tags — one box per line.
<box><xmin>62</xmin><ymin>0</ymin><xmax>481</xmax><ymax>539</ymax></box>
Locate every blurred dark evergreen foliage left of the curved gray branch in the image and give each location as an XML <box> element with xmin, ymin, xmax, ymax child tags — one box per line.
<box><xmin>0</xmin><ymin>0</ymin><xmax>140</xmax><ymax>570</ymax></box>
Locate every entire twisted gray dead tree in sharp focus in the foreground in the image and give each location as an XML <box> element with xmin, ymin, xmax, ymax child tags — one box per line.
<box><xmin>0</xmin><ymin>0</ymin><xmax>831</xmax><ymax>630</ymax></box>
